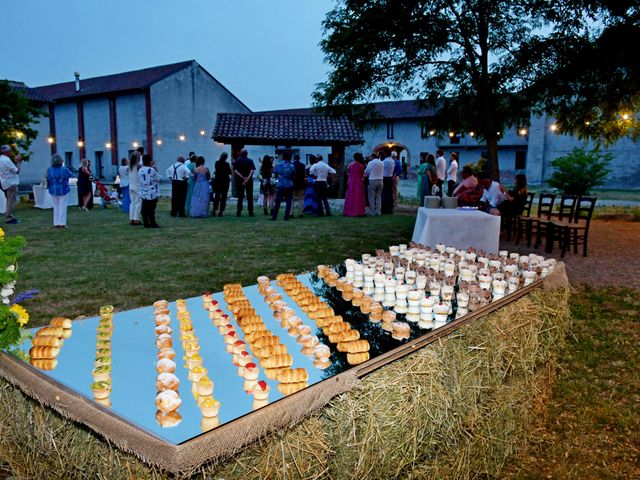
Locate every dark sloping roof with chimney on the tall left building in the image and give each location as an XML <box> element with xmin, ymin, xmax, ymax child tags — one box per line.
<box><xmin>32</xmin><ymin>60</ymin><xmax>195</xmax><ymax>100</ymax></box>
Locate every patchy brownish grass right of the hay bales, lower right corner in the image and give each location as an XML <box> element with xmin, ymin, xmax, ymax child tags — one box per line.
<box><xmin>504</xmin><ymin>287</ymin><xmax>640</xmax><ymax>479</ymax></box>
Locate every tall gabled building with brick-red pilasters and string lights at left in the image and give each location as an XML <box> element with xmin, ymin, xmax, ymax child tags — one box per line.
<box><xmin>21</xmin><ymin>60</ymin><xmax>250</xmax><ymax>184</ymax></box>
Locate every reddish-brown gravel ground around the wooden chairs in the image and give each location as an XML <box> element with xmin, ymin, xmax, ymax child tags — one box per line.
<box><xmin>501</xmin><ymin>220</ymin><xmax>640</xmax><ymax>289</ymax></box>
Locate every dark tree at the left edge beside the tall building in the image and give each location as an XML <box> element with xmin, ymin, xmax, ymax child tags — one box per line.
<box><xmin>0</xmin><ymin>80</ymin><xmax>45</xmax><ymax>159</ymax></box>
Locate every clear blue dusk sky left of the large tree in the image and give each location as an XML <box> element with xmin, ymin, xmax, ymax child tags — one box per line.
<box><xmin>0</xmin><ymin>0</ymin><xmax>334</xmax><ymax>111</ymax></box>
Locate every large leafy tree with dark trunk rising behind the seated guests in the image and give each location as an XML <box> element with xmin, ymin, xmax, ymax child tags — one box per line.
<box><xmin>314</xmin><ymin>0</ymin><xmax>636</xmax><ymax>178</ymax></box>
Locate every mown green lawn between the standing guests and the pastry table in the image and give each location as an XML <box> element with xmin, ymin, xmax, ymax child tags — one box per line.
<box><xmin>4</xmin><ymin>201</ymin><xmax>415</xmax><ymax>326</ymax></box>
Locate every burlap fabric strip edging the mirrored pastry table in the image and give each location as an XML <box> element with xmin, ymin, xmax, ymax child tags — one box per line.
<box><xmin>0</xmin><ymin>263</ymin><xmax>569</xmax><ymax>472</ymax></box>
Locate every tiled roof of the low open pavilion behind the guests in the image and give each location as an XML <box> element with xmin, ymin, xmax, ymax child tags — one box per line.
<box><xmin>213</xmin><ymin>113</ymin><xmax>364</xmax><ymax>146</ymax></box>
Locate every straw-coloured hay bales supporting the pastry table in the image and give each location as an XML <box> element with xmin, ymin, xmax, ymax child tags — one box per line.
<box><xmin>0</xmin><ymin>289</ymin><xmax>570</xmax><ymax>479</ymax></box>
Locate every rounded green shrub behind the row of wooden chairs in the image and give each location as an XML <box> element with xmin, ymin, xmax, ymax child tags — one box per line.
<box><xmin>548</xmin><ymin>147</ymin><xmax>613</xmax><ymax>195</ymax></box>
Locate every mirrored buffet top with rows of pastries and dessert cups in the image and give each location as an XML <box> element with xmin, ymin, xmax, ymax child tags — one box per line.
<box><xmin>17</xmin><ymin>244</ymin><xmax>555</xmax><ymax>444</ymax></box>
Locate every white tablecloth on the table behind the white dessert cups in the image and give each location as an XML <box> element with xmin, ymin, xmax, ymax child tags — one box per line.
<box><xmin>412</xmin><ymin>207</ymin><xmax>500</xmax><ymax>254</ymax></box>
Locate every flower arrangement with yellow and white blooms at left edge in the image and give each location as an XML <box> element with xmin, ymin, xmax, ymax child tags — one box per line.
<box><xmin>0</xmin><ymin>228</ymin><xmax>38</xmax><ymax>352</ymax></box>
